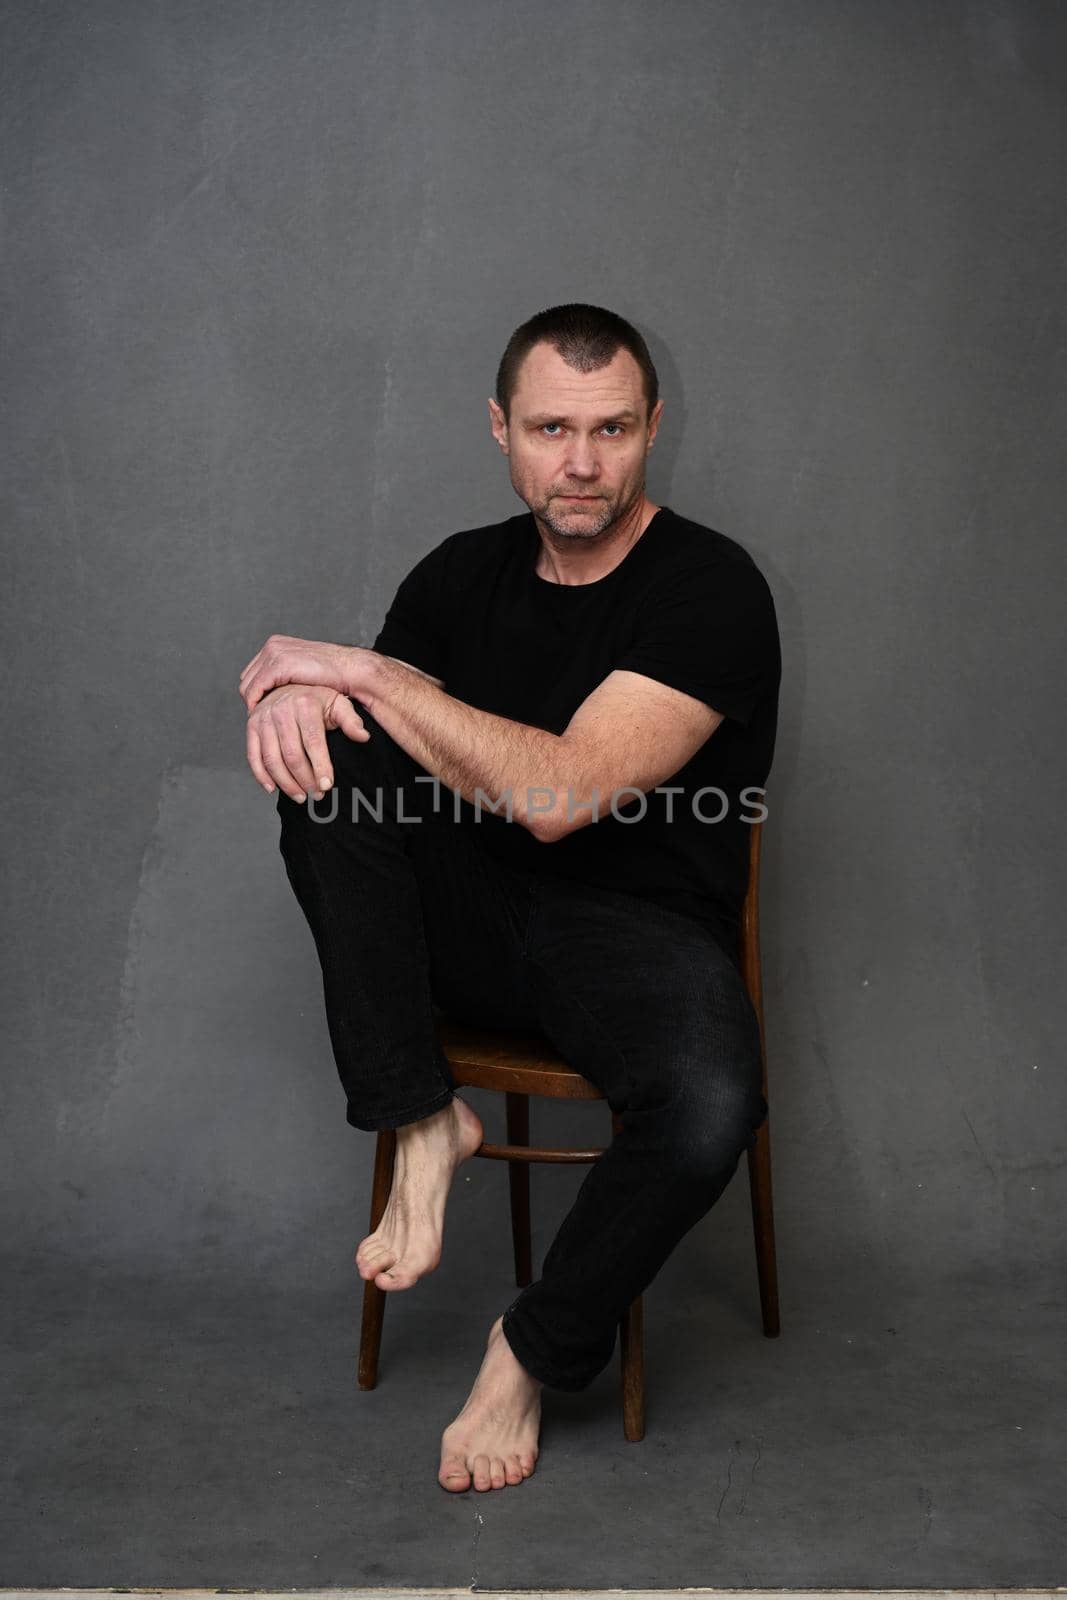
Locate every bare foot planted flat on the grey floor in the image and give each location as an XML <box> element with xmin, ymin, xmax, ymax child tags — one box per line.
<box><xmin>437</xmin><ymin>1317</ymin><xmax>542</xmax><ymax>1494</ymax></box>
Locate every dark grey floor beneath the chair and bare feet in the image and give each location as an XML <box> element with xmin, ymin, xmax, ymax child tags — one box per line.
<box><xmin>0</xmin><ymin>1163</ymin><xmax>1067</xmax><ymax>1589</ymax></box>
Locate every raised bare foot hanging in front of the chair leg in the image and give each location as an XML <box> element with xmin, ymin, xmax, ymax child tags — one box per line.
<box><xmin>355</xmin><ymin>1094</ymin><xmax>482</xmax><ymax>1290</ymax></box>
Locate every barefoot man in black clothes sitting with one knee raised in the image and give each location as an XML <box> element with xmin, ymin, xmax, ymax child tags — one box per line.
<box><xmin>240</xmin><ymin>304</ymin><xmax>781</xmax><ymax>1491</ymax></box>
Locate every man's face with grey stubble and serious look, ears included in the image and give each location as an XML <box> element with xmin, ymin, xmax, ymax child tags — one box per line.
<box><xmin>490</xmin><ymin>344</ymin><xmax>662</xmax><ymax>539</ymax></box>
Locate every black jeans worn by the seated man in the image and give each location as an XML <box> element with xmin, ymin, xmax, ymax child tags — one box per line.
<box><xmin>277</xmin><ymin>706</ymin><xmax>768</xmax><ymax>1390</ymax></box>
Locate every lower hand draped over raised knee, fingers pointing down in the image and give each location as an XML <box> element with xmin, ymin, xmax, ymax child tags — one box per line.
<box><xmin>246</xmin><ymin>683</ymin><xmax>370</xmax><ymax>802</ymax></box>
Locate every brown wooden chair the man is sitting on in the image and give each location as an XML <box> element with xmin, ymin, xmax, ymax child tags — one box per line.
<box><xmin>358</xmin><ymin>822</ymin><xmax>781</xmax><ymax>1440</ymax></box>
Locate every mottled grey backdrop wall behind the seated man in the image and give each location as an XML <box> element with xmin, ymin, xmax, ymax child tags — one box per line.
<box><xmin>2</xmin><ymin>0</ymin><xmax>1067</xmax><ymax>1574</ymax></box>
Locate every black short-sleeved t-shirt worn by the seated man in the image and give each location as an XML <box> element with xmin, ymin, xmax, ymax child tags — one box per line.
<box><xmin>373</xmin><ymin>506</ymin><xmax>781</xmax><ymax>958</ymax></box>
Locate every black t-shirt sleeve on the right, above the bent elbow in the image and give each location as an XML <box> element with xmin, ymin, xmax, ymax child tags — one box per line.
<box><xmin>614</xmin><ymin>562</ymin><xmax>782</xmax><ymax>723</ymax></box>
